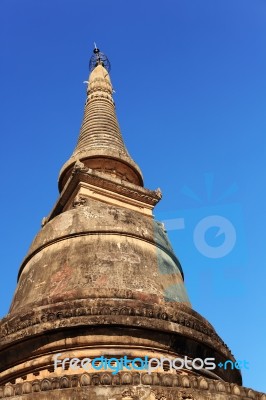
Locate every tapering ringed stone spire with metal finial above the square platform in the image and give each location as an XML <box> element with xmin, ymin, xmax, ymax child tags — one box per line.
<box><xmin>59</xmin><ymin>45</ymin><xmax>143</xmax><ymax>191</ymax></box>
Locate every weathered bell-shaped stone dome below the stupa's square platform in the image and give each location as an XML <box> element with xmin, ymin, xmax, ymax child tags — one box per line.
<box><xmin>11</xmin><ymin>200</ymin><xmax>189</xmax><ymax>313</ymax></box>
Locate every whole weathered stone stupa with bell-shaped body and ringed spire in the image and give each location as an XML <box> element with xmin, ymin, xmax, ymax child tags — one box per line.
<box><xmin>0</xmin><ymin>48</ymin><xmax>266</xmax><ymax>400</ymax></box>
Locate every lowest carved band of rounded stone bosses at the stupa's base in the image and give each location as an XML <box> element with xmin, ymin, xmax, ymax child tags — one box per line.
<box><xmin>0</xmin><ymin>372</ymin><xmax>265</xmax><ymax>400</ymax></box>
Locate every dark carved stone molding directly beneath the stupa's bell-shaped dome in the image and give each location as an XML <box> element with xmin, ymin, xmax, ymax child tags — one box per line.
<box><xmin>0</xmin><ymin>291</ymin><xmax>227</xmax><ymax>348</ymax></box>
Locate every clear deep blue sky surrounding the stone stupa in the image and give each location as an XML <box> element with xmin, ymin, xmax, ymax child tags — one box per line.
<box><xmin>0</xmin><ymin>0</ymin><xmax>266</xmax><ymax>392</ymax></box>
